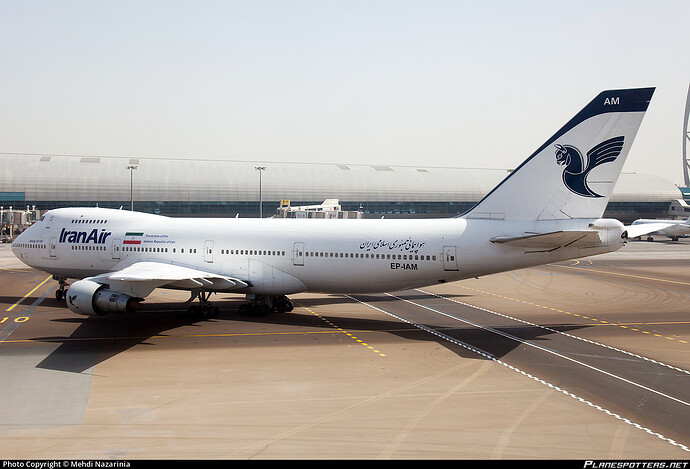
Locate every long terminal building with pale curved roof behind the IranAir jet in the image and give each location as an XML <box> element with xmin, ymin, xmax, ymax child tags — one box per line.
<box><xmin>0</xmin><ymin>154</ymin><xmax>688</xmax><ymax>223</ymax></box>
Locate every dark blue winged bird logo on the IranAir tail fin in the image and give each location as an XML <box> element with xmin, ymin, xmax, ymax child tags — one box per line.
<box><xmin>556</xmin><ymin>136</ymin><xmax>625</xmax><ymax>197</ymax></box>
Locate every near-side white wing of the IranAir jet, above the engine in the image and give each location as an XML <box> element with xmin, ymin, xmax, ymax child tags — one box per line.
<box><xmin>93</xmin><ymin>261</ymin><xmax>249</xmax><ymax>291</ymax></box>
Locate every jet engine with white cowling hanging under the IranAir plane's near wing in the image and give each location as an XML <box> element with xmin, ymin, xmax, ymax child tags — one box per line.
<box><xmin>67</xmin><ymin>279</ymin><xmax>138</xmax><ymax>316</ymax></box>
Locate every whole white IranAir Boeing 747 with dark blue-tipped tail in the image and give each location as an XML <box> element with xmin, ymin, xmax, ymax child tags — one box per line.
<box><xmin>12</xmin><ymin>88</ymin><xmax>654</xmax><ymax>316</ymax></box>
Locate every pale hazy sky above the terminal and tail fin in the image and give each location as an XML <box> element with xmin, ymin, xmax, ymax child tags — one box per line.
<box><xmin>0</xmin><ymin>0</ymin><xmax>690</xmax><ymax>184</ymax></box>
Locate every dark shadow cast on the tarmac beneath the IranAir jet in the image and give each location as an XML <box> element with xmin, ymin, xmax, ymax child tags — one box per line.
<box><xmin>32</xmin><ymin>294</ymin><xmax>586</xmax><ymax>373</ymax></box>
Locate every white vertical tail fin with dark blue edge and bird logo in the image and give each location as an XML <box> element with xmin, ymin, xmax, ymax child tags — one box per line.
<box><xmin>462</xmin><ymin>88</ymin><xmax>654</xmax><ymax>220</ymax></box>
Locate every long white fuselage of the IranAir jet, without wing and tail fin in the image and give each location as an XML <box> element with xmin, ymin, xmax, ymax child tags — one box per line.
<box><xmin>13</xmin><ymin>208</ymin><xmax>623</xmax><ymax>294</ymax></box>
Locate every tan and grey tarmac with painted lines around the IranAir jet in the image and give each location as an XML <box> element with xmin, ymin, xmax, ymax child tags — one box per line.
<box><xmin>0</xmin><ymin>239</ymin><xmax>690</xmax><ymax>460</ymax></box>
